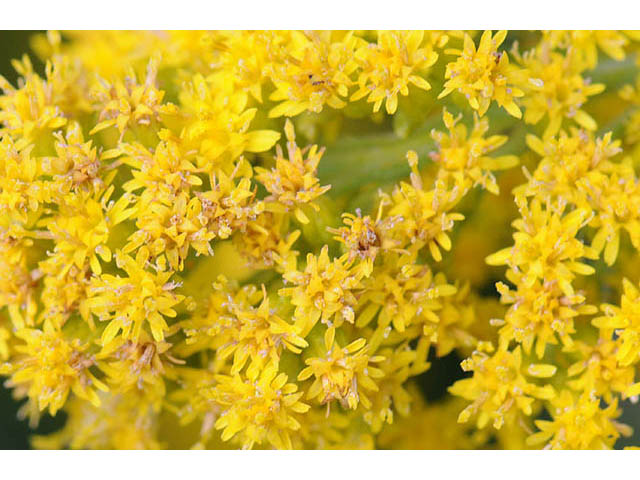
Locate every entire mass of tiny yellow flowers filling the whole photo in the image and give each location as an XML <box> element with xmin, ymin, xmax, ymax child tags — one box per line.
<box><xmin>0</xmin><ymin>31</ymin><xmax>640</xmax><ymax>449</ymax></box>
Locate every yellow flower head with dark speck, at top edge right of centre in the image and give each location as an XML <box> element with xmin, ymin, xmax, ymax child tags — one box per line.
<box><xmin>438</xmin><ymin>30</ymin><xmax>524</xmax><ymax>118</ymax></box>
